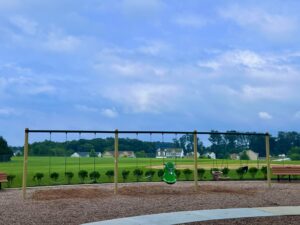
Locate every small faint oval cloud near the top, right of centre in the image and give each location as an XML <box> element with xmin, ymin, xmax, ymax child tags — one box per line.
<box><xmin>174</xmin><ymin>14</ymin><xmax>207</xmax><ymax>28</ymax></box>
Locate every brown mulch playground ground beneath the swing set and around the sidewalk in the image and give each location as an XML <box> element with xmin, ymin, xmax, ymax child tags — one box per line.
<box><xmin>0</xmin><ymin>181</ymin><xmax>300</xmax><ymax>224</ymax></box>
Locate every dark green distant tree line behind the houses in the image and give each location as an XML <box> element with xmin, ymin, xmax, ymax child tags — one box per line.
<box><xmin>0</xmin><ymin>130</ymin><xmax>300</xmax><ymax>161</ymax></box>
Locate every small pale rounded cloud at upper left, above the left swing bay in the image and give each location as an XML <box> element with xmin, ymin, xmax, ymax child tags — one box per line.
<box><xmin>44</xmin><ymin>32</ymin><xmax>81</xmax><ymax>52</ymax></box>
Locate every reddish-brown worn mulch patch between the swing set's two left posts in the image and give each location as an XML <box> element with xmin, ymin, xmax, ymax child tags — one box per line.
<box><xmin>32</xmin><ymin>188</ymin><xmax>113</xmax><ymax>201</ymax></box>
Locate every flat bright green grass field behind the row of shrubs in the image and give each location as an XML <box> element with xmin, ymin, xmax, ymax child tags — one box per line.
<box><xmin>0</xmin><ymin>157</ymin><xmax>300</xmax><ymax>187</ymax></box>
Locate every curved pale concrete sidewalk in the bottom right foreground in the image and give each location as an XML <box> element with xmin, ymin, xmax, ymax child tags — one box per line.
<box><xmin>85</xmin><ymin>206</ymin><xmax>300</xmax><ymax>225</ymax></box>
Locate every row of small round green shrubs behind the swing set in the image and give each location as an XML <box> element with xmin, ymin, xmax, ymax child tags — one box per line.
<box><xmin>1</xmin><ymin>166</ymin><xmax>278</xmax><ymax>187</ymax></box>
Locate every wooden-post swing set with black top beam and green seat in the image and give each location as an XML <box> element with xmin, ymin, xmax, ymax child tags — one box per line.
<box><xmin>22</xmin><ymin>128</ymin><xmax>271</xmax><ymax>199</ymax></box>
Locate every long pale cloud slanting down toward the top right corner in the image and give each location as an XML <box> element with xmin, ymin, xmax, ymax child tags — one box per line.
<box><xmin>220</xmin><ymin>5</ymin><xmax>298</xmax><ymax>38</ymax></box>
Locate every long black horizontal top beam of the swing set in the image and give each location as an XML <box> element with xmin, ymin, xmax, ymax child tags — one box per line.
<box><xmin>25</xmin><ymin>128</ymin><xmax>269</xmax><ymax>136</ymax></box>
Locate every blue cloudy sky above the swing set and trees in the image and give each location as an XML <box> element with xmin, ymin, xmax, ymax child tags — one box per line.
<box><xmin>0</xmin><ymin>0</ymin><xmax>300</xmax><ymax>145</ymax></box>
